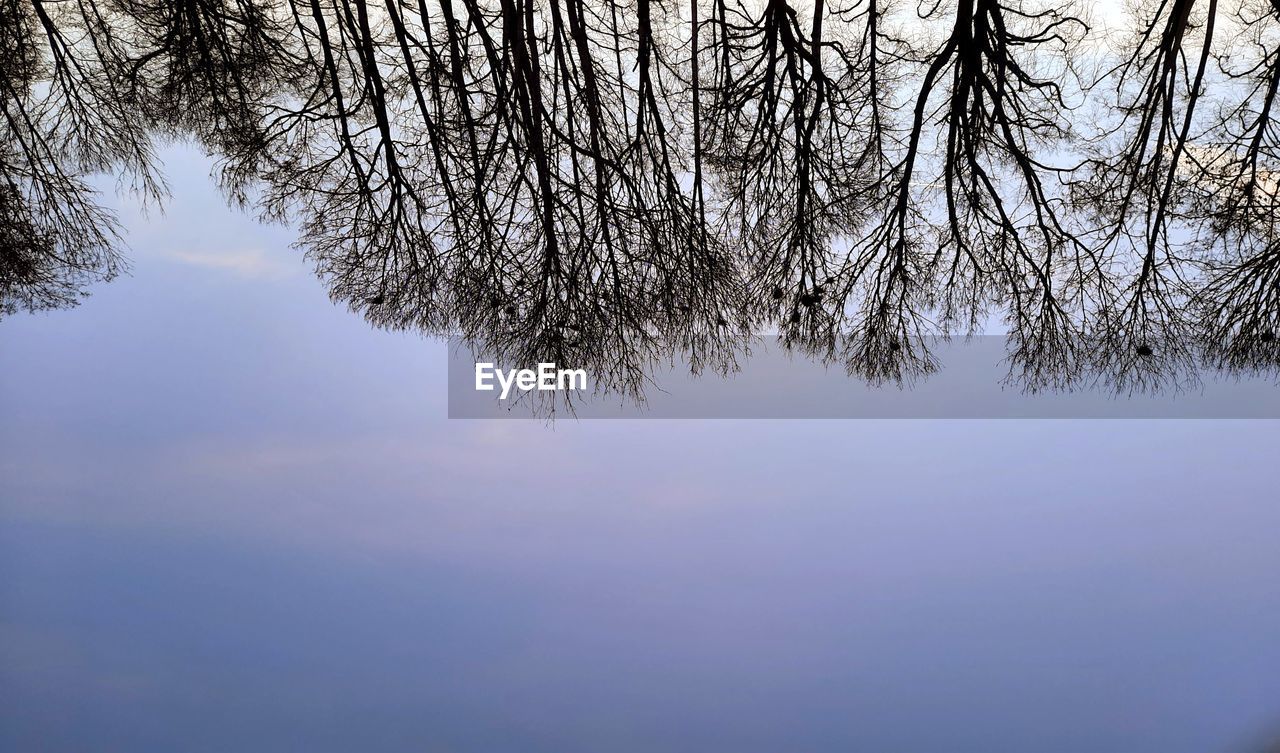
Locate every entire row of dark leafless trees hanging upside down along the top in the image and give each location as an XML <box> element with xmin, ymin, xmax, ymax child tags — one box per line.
<box><xmin>0</xmin><ymin>0</ymin><xmax>1280</xmax><ymax>394</ymax></box>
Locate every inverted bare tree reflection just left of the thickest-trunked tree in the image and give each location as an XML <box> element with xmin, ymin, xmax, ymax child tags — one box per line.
<box><xmin>703</xmin><ymin>0</ymin><xmax>886</xmax><ymax>363</ymax></box>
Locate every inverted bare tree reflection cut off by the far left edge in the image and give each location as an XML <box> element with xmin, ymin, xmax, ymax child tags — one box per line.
<box><xmin>0</xmin><ymin>0</ymin><xmax>159</xmax><ymax>315</ymax></box>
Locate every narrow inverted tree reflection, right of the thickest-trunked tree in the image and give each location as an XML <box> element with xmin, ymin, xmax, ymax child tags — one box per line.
<box><xmin>1078</xmin><ymin>0</ymin><xmax>1217</xmax><ymax>384</ymax></box>
